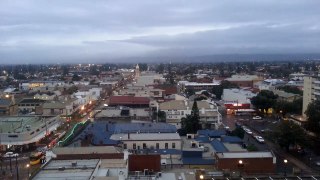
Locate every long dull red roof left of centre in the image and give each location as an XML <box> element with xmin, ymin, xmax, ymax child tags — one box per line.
<box><xmin>109</xmin><ymin>96</ymin><xmax>150</xmax><ymax>105</ymax></box>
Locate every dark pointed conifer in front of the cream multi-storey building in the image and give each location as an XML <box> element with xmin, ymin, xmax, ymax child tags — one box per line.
<box><xmin>181</xmin><ymin>101</ymin><xmax>201</xmax><ymax>134</ymax></box>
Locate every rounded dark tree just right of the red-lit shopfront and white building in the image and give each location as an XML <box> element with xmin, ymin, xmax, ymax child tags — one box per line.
<box><xmin>251</xmin><ymin>90</ymin><xmax>278</xmax><ymax>112</ymax></box>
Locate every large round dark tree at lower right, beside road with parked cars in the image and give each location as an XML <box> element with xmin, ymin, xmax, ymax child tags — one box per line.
<box><xmin>273</xmin><ymin>121</ymin><xmax>306</xmax><ymax>151</ymax></box>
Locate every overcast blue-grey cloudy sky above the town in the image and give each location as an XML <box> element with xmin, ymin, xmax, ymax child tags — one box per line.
<box><xmin>0</xmin><ymin>0</ymin><xmax>320</xmax><ymax>64</ymax></box>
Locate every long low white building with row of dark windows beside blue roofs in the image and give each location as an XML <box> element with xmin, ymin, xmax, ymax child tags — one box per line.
<box><xmin>110</xmin><ymin>133</ymin><xmax>182</xmax><ymax>150</ymax></box>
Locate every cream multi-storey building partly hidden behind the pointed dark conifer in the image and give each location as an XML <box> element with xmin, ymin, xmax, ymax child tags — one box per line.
<box><xmin>159</xmin><ymin>100</ymin><xmax>222</xmax><ymax>128</ymax></box>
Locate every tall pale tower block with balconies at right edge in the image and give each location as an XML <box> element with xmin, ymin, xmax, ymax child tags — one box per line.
<box><xmin>302</xmin><ymin>74</ymin><xmax>320</xmax><ymax>116</ymax></box>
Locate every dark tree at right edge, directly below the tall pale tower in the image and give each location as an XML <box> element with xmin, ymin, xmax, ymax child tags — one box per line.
<box><xmin>305</xmin><ymin>100</ymin><xmax>320</xmax><ymax>136</ymax></box>
